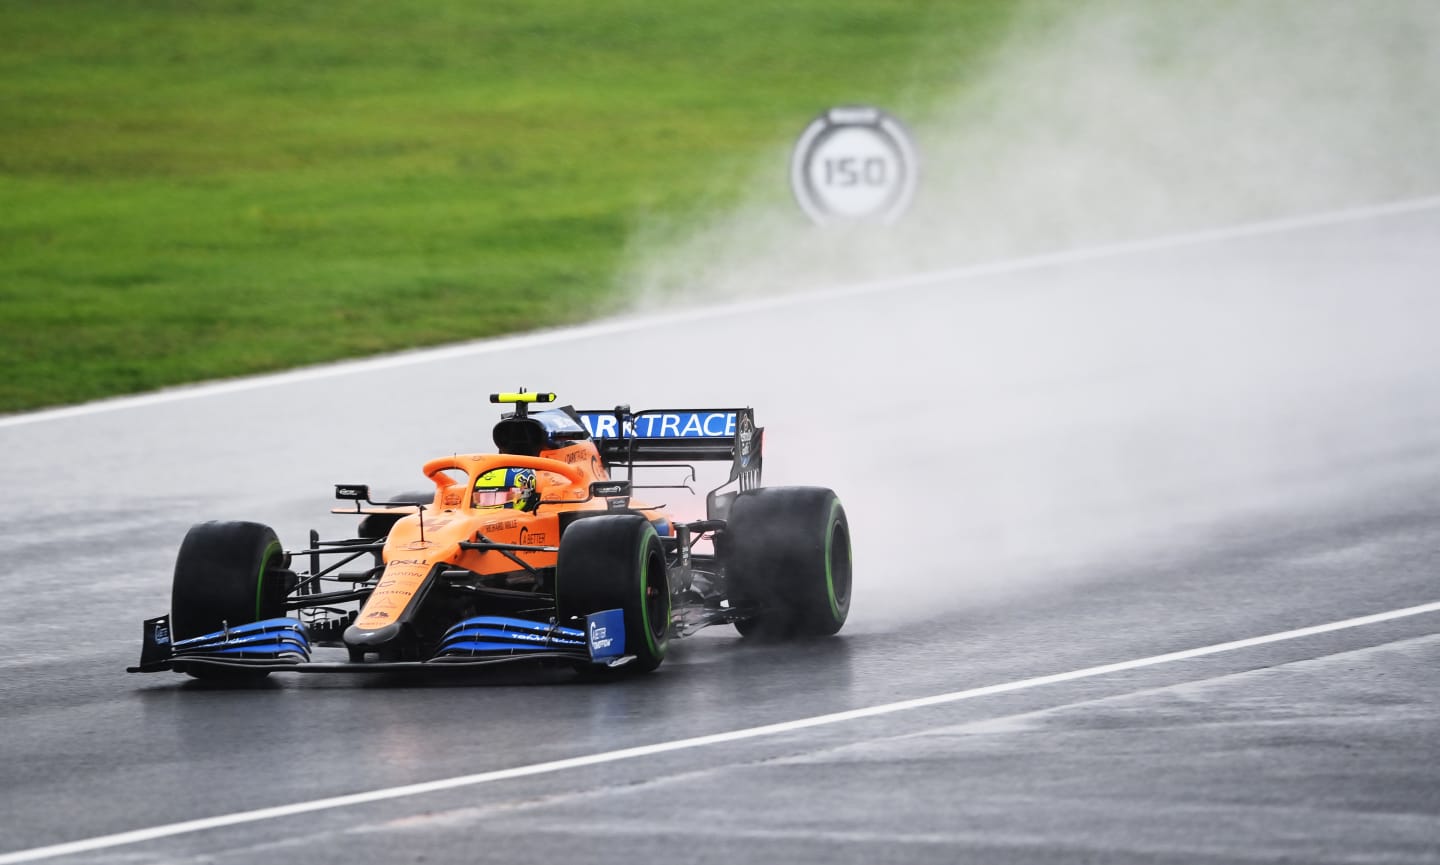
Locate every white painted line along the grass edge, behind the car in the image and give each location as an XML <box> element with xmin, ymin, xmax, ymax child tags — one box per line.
<box><xmin>0</xmin><ymin>196</ymin><xmax>1440</xmax><ymax>429</ymax></box>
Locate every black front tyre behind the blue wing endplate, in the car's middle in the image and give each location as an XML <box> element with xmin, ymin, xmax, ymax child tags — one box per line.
<box><xmin>554</xmin><ymin>514</ymin><xmax>670</xmax><ymax>675</ymax></box>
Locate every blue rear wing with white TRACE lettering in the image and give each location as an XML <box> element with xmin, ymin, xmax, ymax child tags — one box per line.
<box><xmin>575</xmin><ymin>406</ymin><xmax>765</xmax><ymax>489</ymax></box>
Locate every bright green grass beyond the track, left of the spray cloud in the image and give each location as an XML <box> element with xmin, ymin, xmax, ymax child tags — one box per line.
<box><xmin>0</xmin><ymin>0</ymin><xmax>1011</xmax><ymax>412</ymax></box>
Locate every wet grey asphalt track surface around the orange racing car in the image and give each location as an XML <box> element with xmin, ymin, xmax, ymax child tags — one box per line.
<box><xmin>8</xmin><ymin>204</ymin><xmax>1440</xmax><ymax>864</ymax></box>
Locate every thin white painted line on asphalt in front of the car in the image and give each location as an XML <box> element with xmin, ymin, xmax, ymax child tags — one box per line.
<box><xmin>0</xmin><ymin>602</ymin><xmax>1440</xmax><ymax>865</ymax></box>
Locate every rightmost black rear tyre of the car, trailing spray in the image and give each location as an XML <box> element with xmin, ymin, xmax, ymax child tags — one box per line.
<box><xmin>723</xmin><ymin>486</ymin><xmax>851</xmax><ymax>639</ymax></box>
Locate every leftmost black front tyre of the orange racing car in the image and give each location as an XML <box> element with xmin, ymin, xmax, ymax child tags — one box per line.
<box><xmin>170</xmin><ymin>521</ymin><xmax>291</xmax><ymax>679</ymax></box>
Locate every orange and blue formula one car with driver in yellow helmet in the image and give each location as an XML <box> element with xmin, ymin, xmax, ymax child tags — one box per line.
<box><xmin>128</xmin><ymin>390</ymin><xmax>851</xmax><ymax>679</ymax></box>
